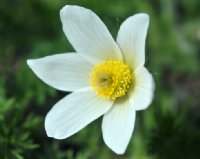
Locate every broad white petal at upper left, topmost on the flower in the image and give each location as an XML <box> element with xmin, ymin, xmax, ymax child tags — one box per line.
<box><xmin>60</xmin><ymin>6</ymin><xmax>122</xmax><ymax>64</ymax></box>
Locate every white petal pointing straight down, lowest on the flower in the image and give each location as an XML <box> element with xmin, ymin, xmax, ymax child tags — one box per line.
<box><xmin>102</xmin><ymin>97</ymin><xmax>135</xmax><ymax>154</ymax></box>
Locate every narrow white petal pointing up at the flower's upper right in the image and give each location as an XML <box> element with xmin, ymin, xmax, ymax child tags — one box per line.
<box><xmin>117</xmin><ymin>13</ymin><xmax>149</xmax><ymax>69</ymax></box>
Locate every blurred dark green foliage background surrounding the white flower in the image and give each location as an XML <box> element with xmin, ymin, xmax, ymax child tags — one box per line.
<box><xmin>0</xmin><ymin>0</ymin><xmax>200</xmax><ymax>159</ymax></box>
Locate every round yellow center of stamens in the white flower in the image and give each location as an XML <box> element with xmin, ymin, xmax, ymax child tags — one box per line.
<box><xmin>90</xmin><ymin>60</ymin><xmax>132</xmax><ymax>100</ymax></box>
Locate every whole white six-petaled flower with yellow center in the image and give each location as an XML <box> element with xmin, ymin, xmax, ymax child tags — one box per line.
<box><xmin>27</xmin><ymin>6</ymin><xmax>154</xmax><ymax>154</ymax></box>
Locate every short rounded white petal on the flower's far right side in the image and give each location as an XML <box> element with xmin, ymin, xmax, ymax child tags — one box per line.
<box><xmin>129</xmin><ymin>67</ymin><xmax>154</xmax><ymax>110</ymax></box>
